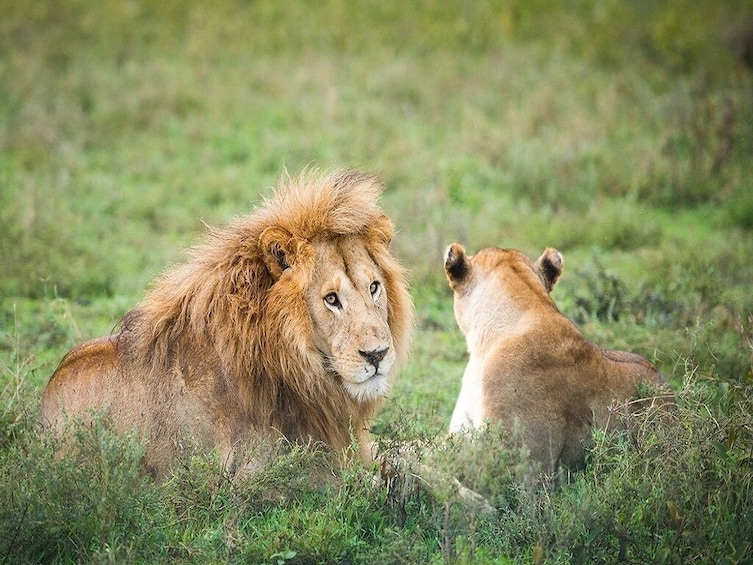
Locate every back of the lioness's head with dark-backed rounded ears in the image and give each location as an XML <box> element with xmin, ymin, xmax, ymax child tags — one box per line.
<box><xmin>444</xmin><ymin>243</ymin><xmax>564</xmax><ymax>335</ymax></box>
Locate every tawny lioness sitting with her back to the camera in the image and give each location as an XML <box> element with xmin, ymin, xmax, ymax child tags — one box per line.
<box><xmin>444</xmin><ymin>243</ymin><xmax>664</xmax><ymax>472</ymax></box>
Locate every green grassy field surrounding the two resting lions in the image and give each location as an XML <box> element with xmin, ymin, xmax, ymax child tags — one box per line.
<box><xmin>0</xmin><ymin>0</ymin><xmax>753</xmax><ymax>565</ymax></box>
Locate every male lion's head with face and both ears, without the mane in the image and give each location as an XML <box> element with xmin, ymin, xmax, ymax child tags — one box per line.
<box><xmin>260</xmin><ymin>216</ymin><xmax>404</xmax><ymax>402</ymax></box>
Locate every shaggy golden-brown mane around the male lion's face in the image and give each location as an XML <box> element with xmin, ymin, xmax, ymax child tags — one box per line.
<box><xmin>43</xmin><ymin>170</ymin><xmax>413</xmax><ymax>472</ymax></box>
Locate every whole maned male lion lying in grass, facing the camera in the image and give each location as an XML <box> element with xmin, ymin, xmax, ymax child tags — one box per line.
<box><xmin>41</xmin><ymin>171</ymin><xmax>413</xmax><ymax>476</ymax></box>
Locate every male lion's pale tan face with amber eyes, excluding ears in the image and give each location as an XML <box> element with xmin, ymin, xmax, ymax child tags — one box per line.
<box><xmin>306</xmin><ymin>237</ymin><xmax>395</xmax><ymax>401</ymax></box>
